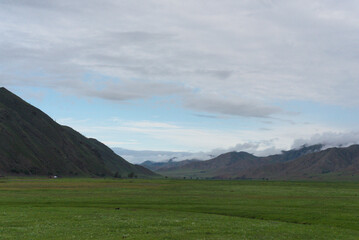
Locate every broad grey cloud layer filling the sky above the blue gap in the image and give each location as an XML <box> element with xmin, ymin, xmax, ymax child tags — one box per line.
<box><xmin>0</xmin><ymin>0</ymin><xmax>359</xmax><ymax>118</ymax></box>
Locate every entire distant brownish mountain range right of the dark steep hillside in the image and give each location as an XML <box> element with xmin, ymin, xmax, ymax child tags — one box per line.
<box><xmin>149</xmin><ymin>144</ymin><xmax>359</xmax><ymax>180</ymax></box>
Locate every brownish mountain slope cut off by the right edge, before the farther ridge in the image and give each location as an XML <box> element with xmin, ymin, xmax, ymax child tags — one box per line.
<box><xmin>237</xmin><ymin>145</ymin><xmax>359</xmax><ymax>180</ymax></box>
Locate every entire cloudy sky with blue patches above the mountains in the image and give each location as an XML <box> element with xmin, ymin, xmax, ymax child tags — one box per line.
<box><xmin>0</xmin><ymin>0</ymin><xmax>359</xmax><ymax>160</ymax></box>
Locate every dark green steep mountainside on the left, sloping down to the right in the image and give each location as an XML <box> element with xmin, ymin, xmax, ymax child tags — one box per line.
<box><xmin>0</xmin><ymin>88</ymin><xmax>156</xmax><ymax>177</ymax></box>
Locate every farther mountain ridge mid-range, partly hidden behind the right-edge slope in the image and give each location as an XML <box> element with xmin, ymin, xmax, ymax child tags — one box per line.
<box><xmin>155</xmin><ymin>145</ymin><xmax>322</xmax><ymax>178</ymax></box>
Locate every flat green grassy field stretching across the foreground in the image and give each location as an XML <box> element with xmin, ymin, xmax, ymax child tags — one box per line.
<box><xmin>0</xmin><ymin>179</ymin><xmax>359</xmax><ymax>239</ymax></box>
